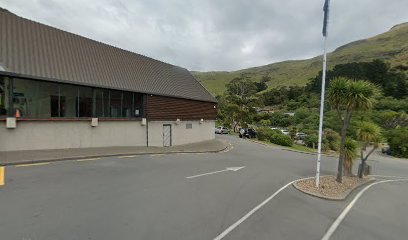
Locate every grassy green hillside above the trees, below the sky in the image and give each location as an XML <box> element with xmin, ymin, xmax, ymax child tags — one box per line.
<box><xmin>192</xmin><ymin>23</ymin><xmax>408</xmax><ymax>95</ymax></box>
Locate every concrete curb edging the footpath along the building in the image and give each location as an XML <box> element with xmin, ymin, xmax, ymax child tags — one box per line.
<box><xmin>0</xmin><ymin>141</ymin><xmax>231</xmax><ymax>166</ymax></box>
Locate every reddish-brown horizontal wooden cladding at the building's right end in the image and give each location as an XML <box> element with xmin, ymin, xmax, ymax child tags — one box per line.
<box><xmin>146</xmin><ymin>95</ymin><xmax>217</xmax><ymax>120</ymax></box>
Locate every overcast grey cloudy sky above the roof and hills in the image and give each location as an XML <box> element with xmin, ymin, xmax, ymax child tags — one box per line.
<box><xmin>0</xmin><ymin>0</ymin><xmax>408</xmax><ymax>71</ymax></box>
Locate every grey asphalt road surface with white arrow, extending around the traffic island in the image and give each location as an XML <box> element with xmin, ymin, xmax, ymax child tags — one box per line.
<box><xmin>0</xmin><ymin>136</ymin><xmax>408</xmax><ymax>240</ymax></box>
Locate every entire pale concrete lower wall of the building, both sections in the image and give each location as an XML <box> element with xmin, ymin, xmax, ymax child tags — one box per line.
<box><xmin>0</xmin><ymin>120</ymin><xmax>215</xmax><ymax>151</ymax></box>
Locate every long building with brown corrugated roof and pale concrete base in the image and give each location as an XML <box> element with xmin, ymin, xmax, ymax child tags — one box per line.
<box><xmin>0</xmin><ymin>8</ymin><xmax>216</xmax><ymax>151</ymax></box>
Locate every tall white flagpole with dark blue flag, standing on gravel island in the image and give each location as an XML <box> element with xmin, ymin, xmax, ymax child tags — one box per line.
<box><xmin>316</xmin><ymin>0</ymin><xmax>330</xmax><ymax>188</ymax></box>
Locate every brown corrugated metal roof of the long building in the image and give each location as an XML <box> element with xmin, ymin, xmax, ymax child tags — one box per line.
<box><xmin>0</xmin><ymin>8</ymin><xmax>216</xmax><ymax>102</ymax></box>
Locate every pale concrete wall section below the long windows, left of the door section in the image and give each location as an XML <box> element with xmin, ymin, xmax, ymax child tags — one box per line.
<box><xmin>0</xmin><ymin>121</ymin><xmax>146</xmax><ymax>151</ymax></box>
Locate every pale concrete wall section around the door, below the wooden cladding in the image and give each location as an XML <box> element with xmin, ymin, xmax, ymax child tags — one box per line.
<box><xmin>149</xmin><ymin>120</ymin><xmax>215</xmax><ymax>147</ymax></box>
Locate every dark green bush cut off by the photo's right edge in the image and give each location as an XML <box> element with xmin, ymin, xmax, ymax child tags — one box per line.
<box><xmin>387</xmin><ymin>127</ymin><xmax>408</xmax><ymax>158</ymax></box>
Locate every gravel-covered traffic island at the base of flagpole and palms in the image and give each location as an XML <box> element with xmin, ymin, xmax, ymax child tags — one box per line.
<box><xmin>293</xmin><ymin>176</ymin><xmax>375</xmax><ymax>200</ymax></box>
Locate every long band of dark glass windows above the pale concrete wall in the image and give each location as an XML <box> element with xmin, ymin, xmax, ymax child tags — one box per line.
<box><xmin>8</xmin><ymin>78</ymin><xmax>143</xmax><ymax>118</ymax></box>
